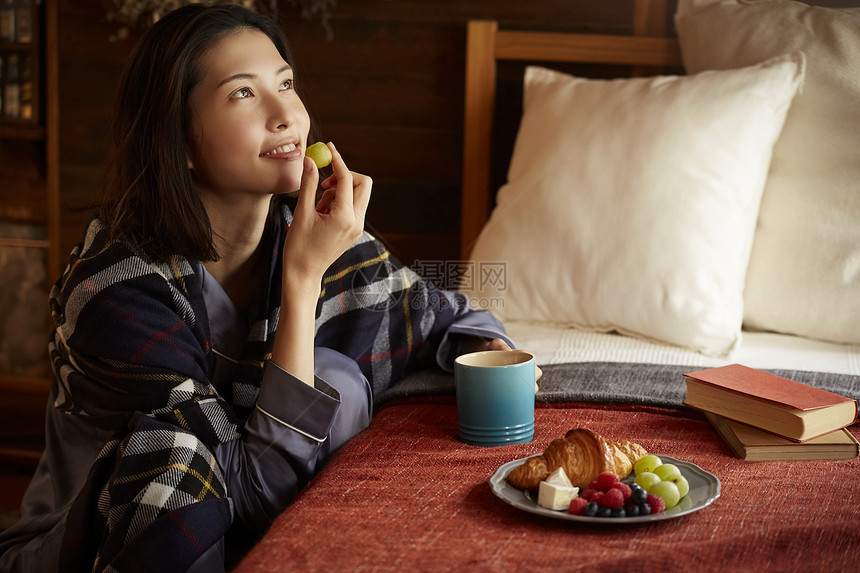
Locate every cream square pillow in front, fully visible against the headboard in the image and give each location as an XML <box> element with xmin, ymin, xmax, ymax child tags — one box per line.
<box><xmin>468</xmin><ymin>57</ymin><xmax>803</xmax><ymax>355</ymax></box>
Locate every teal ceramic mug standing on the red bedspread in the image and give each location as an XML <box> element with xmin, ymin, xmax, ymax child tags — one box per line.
<box><xmin>454</xmin><ymin>350</ymin><xmax>535</xmax><ymax>446</ymax></box>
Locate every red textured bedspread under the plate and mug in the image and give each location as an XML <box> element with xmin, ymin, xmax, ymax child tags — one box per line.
<box><xmin>236</xmin><ymin>399</ymin><xmax>860</xmax><ymax>573</ymax></box>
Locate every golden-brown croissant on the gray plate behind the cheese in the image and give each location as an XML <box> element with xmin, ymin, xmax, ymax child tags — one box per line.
<box><xmin>508</xmin><ymin>428</ymin><xmax>648</xmax><ymax>490</ymax></box>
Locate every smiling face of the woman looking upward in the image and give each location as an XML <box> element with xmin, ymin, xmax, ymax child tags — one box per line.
<box><xmin>188</xmin><ymin>29</ymin><xmax>310</xmax><ymax>202</ymax></box>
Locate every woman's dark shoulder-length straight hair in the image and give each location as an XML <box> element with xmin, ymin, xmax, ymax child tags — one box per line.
<box><xmin>99</xmin><ymin>4</ymin><xmax>293</xmax><ymax>261</ymax></box>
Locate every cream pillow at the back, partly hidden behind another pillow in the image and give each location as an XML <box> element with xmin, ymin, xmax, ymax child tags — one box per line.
<box><xmin>675</xmin><ymin>0</ymin><xmax>860</xmax><ymax>343</ymax></box>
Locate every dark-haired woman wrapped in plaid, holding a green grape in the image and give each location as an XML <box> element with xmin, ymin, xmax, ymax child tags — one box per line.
<box><xmin>0</xmin><ymin>5</ymin><xmax>520</xmax><ymax>571</ymax></box>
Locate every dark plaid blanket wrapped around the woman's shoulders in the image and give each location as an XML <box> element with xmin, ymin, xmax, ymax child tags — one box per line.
<box><xmin>50</xmin><ymin>208</ymin><xmax>472</xmax><ymax>571</ymax></box>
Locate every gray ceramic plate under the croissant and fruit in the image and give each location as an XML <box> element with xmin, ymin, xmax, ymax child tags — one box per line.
<box><xmin>490</xmin><ymin>456</ymin><xmax>720</xmax><ymax>525</ymax></box>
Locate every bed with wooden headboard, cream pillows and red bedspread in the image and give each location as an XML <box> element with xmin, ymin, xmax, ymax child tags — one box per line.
<box><xmin>235</xmin><ymin>0</ymin><xmax>860</xmax><ymax>572</ymax></box>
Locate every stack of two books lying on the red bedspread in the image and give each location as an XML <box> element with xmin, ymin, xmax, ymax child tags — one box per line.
<box><xmin>684</xmin><ymin>364</ymin><xmax>860</xmax><ymax>461</ymax></box>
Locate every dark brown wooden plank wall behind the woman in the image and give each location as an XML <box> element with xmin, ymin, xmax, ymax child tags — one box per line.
<box><xmin>53</xmin><ymin>0</ymin><xmax>644</xmax><ymax>264</ymax></box>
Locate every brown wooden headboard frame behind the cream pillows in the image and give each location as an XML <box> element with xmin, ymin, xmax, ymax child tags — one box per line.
<box><xmin>460</xmin><ymin>0</ymin><xmax>682</xmax><ymax>260</ymax></box>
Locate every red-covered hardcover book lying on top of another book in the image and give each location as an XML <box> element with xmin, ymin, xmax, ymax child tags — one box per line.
<box><xmin>684</xmin><ymin>364</ymin><xmax>857</xmax><ymax>442</ymax></box>
